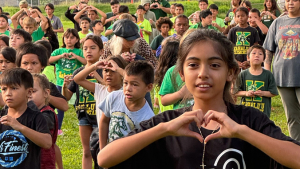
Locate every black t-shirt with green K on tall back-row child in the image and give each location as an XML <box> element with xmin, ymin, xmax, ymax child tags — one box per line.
<box><xmin>227</xmin><ymin>26</ymin><xmax>259</xmax><ymax>62</ymax></box>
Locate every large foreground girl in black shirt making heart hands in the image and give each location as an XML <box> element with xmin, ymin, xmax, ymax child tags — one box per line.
<box><xmin>98</xmin><ymin>30</ymin><xmax>300</xmax><ymax>169</ymax></box>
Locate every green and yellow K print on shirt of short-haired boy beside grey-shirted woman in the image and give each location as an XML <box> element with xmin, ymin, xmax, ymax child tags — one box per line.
<box><xmin>242</xmin><ymin>80</ymin><xmax>265</xmax><ymax>112</ymax></box>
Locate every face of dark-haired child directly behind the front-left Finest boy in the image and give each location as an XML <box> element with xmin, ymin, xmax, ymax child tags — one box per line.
<box><xmin>20</xmin><ymin>53</ymin><xmax>44</xmax><ymax>73</ymax></box>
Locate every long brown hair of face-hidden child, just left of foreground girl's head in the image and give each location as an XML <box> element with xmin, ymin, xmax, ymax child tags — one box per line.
<box><xmin>154</xmin><ymin>38</ymin><xmax>179</xmax><ymax>87</ymax></box>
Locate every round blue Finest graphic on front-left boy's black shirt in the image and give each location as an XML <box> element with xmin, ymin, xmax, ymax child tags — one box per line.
<box><xmin>0</xmin><ymin>130</ymin><xmax>29</xmax><ymax>168</ymax></box>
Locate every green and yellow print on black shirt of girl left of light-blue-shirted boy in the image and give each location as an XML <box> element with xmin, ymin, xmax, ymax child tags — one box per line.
<box><xmin>76</xmin><ymin>79</ymin><xmax>97</xmax><ymax>115</ymax></box>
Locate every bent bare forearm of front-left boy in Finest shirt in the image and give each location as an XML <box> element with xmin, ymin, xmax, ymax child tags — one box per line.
<box><xmin>1</xmin><ymin>115</ymin><xmax>52</xmax><ymax>149</ymax></box>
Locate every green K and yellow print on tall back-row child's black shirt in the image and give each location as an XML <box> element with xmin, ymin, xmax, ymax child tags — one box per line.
<box><xmin>234</xmin><ymin>31</ymin><xmax>251</xmax><ymax>54</ymax></box>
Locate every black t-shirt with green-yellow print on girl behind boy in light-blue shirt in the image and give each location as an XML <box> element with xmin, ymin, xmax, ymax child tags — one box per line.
<box><xmin>68</xmin><ymin>67</ymin><xmax>102</xmax><ymax>125</ymax></box>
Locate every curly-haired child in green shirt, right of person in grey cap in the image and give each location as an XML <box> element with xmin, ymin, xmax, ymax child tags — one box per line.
<box><xmin>150</xmin><ymin>17</ymin><xmax>173</xmax><ymax>54</ymax></box>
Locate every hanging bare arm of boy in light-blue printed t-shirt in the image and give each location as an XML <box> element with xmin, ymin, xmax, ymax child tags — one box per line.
<box><xmin>99</xmin><ymin>113</ymin><xmax>110</xmax><ymax>150</ymax></box>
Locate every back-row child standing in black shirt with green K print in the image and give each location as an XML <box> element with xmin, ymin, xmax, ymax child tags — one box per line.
<box><xmin>227</xmin><ymin>7</ymin><xmax>259</xmax><ymax>69</ymax></box>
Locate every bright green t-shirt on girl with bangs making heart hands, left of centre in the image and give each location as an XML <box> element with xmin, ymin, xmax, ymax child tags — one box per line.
<box><xmin>51</xmin><ymin>48</ymin><xmax>84</xmax><ymax>86</ymax></box>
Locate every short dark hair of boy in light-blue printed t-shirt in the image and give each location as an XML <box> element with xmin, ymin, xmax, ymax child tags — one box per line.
<box><xmin>125</xmin><ymin>60</ymin><xmax>154</xmax><ymax>85</ymax></box>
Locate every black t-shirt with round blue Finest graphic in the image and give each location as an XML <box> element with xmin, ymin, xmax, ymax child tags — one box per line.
<box><xmin>0</xmin><ymin>107</ymin><xmax>50</xmax><ymax>169</ymax></box>
